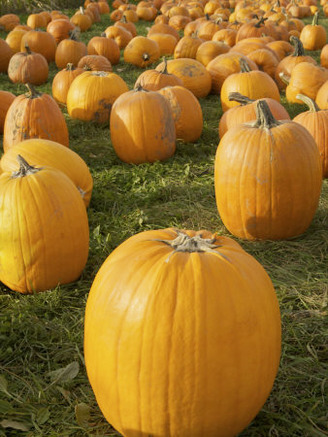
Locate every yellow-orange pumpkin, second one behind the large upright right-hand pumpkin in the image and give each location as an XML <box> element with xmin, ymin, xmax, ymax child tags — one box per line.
<box><xmin>220</xmin><ymin>59</ymin><xmax>280</xmax><ymax>111</ymax></box>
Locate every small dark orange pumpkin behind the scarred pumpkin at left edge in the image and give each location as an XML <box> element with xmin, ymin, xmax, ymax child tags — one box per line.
<box><xmin>8</xmin><ymin>44</ymin><xmax>49</xmax><ymax>85</ymax></box>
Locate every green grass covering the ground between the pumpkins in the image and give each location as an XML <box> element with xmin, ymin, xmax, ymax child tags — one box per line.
<box><xmin>0</xmin><ymin>5</ymin><xmax>328</xmax><ymax>437</ymax></box>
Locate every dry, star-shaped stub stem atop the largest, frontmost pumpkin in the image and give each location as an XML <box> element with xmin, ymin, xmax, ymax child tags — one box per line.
<box><xmin>154</xmin><ymin>229</ymin><xmax>229</xmax><ymax>262</ymax></box>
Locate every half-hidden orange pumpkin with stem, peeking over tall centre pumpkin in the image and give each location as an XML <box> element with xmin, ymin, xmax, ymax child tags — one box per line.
<box><xmin>134</xmin><ymin>58</ymin><xmax>183</xmax><ymax>91</ymax></box>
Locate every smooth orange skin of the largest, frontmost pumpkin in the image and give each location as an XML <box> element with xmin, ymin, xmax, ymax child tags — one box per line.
<box><xmin>84</xmin><ymin>229</ymin><xmax>281</xmax><ymax>437</ymax></box>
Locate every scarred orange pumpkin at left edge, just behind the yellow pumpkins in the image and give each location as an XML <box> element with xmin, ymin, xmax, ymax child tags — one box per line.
<box><xmin>3</xmin><ymin>85</ymin><xmax>69</xmax><ymax>152</ymax></box>
